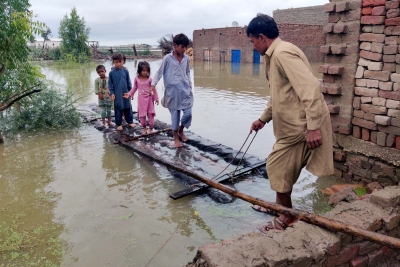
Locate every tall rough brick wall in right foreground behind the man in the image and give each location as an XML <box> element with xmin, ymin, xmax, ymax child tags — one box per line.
<box><xmin>319</xmin><ymin>0</ymin><xmax>400</xmax><ymax>185</ymax></box>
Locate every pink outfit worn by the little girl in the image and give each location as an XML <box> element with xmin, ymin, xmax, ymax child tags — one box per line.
<box><xmin>129</xmin><ymin>77</ymin><xmax>158</xmax><ymax>129</ymax></box>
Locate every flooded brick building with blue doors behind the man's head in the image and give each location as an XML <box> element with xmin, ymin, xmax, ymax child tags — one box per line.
<box><xmin>193</xmin><ymin>6</ymin><xmax>328</xmax><ymax>63</ymax></box>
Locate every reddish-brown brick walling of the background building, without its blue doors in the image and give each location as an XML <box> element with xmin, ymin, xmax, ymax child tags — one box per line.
<box><xmin>193</xmin><ymin>23</ymin><xmax>325</xmax><ymax>63</ymax></box>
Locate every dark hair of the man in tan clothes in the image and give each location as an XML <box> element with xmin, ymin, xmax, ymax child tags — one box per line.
<box><xmin>246</xmin><ymin>13</ymin><xmax>279</xmax><ymax>39</ymax></box>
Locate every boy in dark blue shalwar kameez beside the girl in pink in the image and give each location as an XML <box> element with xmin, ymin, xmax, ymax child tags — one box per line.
<box><xmin>108</xmin><ymin>54</ymin><xmax>136</xmax><ymax>131</ymax></box>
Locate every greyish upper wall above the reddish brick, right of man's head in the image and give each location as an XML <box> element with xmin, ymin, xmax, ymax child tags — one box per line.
<box><xmin>272</xmin><ymin>6</ymin><xmax>328</xmax><ymax>25</ymax></box>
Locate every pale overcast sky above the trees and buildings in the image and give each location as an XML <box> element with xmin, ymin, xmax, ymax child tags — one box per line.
<box><xmin>30</xmin><ymin>0</ymin><xmax>329</xmax><ymax>46</ymax></box>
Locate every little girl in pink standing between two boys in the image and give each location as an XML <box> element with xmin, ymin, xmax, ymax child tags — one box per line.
<box><xmin>124</xmin><ymin>62</ymin><xmax>158</xmax><ymax>134</ymax></box>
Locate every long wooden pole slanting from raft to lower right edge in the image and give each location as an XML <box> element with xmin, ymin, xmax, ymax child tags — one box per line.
<box><xmin>118</xmin><ymin>137</ymin><xmax>400</xmax><ymax>249</ymax></box>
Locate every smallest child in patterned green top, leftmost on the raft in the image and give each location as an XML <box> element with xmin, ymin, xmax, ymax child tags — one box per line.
<box><xmin>94</xmin><ymin>65</ymin><xmax>114</xmax><ymax>127</ymax></box>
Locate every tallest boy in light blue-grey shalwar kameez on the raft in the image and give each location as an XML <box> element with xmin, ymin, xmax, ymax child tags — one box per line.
<box><xmin>151</xmin><ymin>33</ymin><xmax>193</xmax><ymax>148</ymax></box>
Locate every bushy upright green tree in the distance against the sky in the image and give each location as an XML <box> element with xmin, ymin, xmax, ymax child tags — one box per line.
<box><xmin>58</xmin><ymin>7</ymin><xmax>90</xmax><ymax>62</ymax></box>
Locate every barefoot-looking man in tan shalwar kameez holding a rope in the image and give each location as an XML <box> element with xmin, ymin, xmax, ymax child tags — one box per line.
<box><xmin>246</xmin><ymin>14</ymin><xmax>333</xmax><ymax>232</ymax></box>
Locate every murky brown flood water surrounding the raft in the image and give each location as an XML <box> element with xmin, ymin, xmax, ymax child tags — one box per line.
<box><xmin>0</xmin><ymin>60</ymin><xmax>344</xmax><ymax>267</ymax></box>
